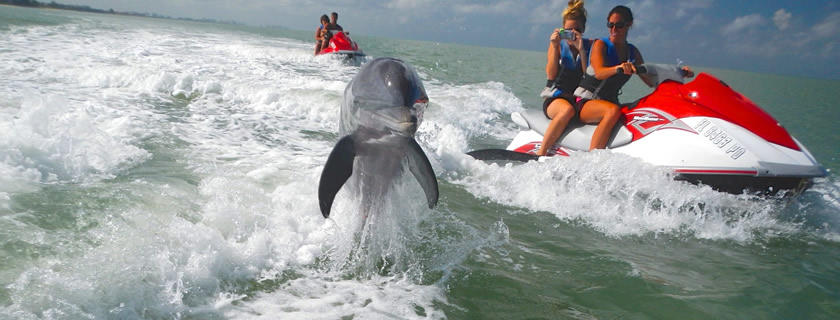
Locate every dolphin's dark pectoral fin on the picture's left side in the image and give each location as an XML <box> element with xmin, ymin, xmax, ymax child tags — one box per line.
<box><xmin>318</xmin><ymin>135</ymin><xmax>356</xmax><ymax>218</ymax></box>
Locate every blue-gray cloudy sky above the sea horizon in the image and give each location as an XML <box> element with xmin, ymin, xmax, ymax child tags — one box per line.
<box><xmin>56</xmin><ymin>0</ymin><xmax>840</xmax><ymax>80</ymax></box>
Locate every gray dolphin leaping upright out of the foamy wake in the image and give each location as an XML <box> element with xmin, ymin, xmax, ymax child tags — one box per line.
<box><xmin>318</xmin><ymin>58</ymin><xmax>438</xmax><ymax>218</ymax></box>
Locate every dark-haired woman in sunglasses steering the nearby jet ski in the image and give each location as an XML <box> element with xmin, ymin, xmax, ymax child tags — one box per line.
<box><xmin>575</xmin><ymin>6</ymin><xmax>694</xmax><ymax>150</ymax></box>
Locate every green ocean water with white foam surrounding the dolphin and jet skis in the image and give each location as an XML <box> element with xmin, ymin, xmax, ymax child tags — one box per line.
<box><xmin>0</xmin><ymin>6</ymin><xmax>840</xmax><ymax>319</ymax></box>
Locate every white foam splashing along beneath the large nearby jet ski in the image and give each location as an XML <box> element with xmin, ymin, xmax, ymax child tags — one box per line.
<box><xmin>457</xmin><ymin>151</ymin><xmax>798</xmax><ymax>241</ymax></box>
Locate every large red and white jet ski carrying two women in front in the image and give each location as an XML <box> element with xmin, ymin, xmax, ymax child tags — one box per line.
<box><xmin>469</xmin><ymin>64</ymin><xmax>827</xmax><ymax>193</ymax></box>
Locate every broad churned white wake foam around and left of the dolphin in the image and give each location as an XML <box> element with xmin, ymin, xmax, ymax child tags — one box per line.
<box><xmin>0</xmin><ymin>16</ymin><xmax>502</xmax><ymax>318</ymax></box>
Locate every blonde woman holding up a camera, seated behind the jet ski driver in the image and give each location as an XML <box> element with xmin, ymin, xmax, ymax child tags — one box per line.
<box><xmin>537</xmin><ymin>0</ymin><xmax>592</xmax><ymax>156</ymax></box>
